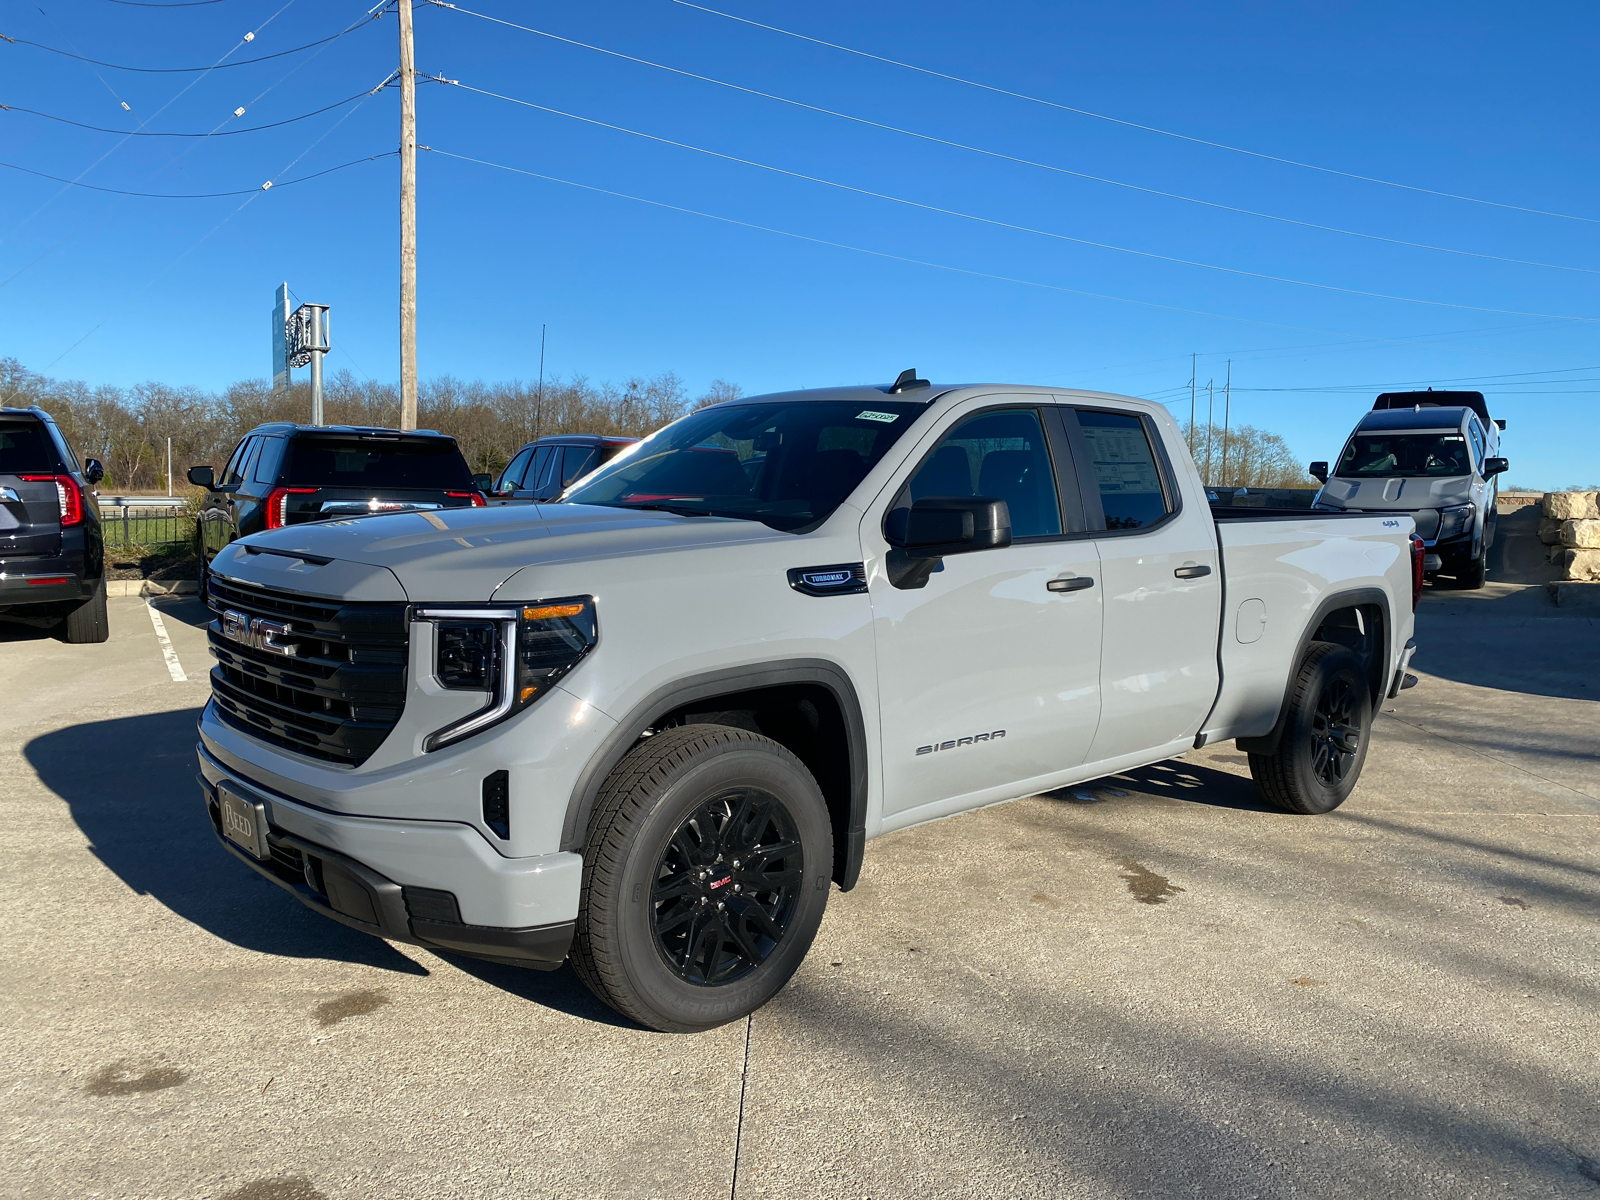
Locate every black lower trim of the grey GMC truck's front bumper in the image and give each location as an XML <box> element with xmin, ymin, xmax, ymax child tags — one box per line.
<box><xmin>200</xmin><ymin>776</ymin><xmax>574</xmax><ymax>971</ymax></box>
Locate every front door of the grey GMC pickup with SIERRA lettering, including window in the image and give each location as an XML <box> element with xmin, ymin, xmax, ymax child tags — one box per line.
<box><xmin>862</xmin><ymin>397</ymin><xmax>1102</xmax><ymax>824</ymax></box>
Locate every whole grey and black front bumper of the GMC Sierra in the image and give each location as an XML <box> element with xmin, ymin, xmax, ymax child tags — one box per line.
<box><xmin>197</xmin><ymin>747</ymin><xmax>582</xmax><ymax>970</ymax></box>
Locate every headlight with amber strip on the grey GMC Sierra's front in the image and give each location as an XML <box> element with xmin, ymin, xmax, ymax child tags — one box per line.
<box><xmin>414</xmin><ymin>595</ymin><xmax>600</xmax><ymax>752</ymax></box>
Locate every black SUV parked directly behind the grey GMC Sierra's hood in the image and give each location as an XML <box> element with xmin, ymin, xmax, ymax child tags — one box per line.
<box><xmin>189</xmin><ymin>421</ymin><xmax>490</xmax><ymax>578</ymax></box>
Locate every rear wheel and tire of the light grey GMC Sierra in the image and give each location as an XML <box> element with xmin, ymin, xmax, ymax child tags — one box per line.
<box><xmin>1250</xmin><ymin>642</ymin><xmax>1373</xmax><ymax>816</ymax></box>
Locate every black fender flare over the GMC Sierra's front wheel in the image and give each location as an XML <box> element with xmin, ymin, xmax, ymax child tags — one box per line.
<box><xmin>562</xmin><ymin>659</ymin><xmax>867</xmax><ymax>891</ymax></box>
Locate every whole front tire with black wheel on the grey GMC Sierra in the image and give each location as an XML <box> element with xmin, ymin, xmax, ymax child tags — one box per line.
<box><xmin>571</xmin><ymin>725</ymin><xmax>834</xmax><ymax>1032</ymax></box>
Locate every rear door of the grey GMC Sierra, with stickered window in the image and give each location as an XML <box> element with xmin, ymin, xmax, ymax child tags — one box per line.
<box><xmin>1061</xmin><ymin>405</ymin><xmax>1222</xmax><ymax>762</ymax></box>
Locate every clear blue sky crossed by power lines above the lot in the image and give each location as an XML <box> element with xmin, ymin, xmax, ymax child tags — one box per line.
<box><xmin>0</xmin><ymin>0</ymin><xmax>1600</xmax><ymax>486</ymax></box>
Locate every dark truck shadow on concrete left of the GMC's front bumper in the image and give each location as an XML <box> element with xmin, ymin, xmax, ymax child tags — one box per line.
<box><xmin>24</xmin><ymin>709</ymin><xmax>427</xmax><ymax>974</ymax></box>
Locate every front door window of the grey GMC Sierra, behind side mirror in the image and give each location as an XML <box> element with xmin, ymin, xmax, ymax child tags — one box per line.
<box><xmin>891</xmin><ymin>408</ymin><xmax>1061</xmax><ymax>541</ymax></box>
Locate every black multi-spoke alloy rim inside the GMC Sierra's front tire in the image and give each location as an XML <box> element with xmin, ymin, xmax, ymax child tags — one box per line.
<box><xmin>651</xmin><ymin>787</ymin><xmax>805</xmax><ymax>986</ymax></box>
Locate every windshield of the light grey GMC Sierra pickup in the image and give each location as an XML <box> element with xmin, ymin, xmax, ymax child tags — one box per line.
<box><xmin>562</xmin><ymin>398</ymin><xmax>925</xmax><ymax>530</ymax></box>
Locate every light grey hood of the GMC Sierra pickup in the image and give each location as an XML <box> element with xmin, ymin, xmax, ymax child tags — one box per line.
<box><xmin>213</xmin><ymin>504</ymin><xmax>792</xmax><ymax>603</ymax></box>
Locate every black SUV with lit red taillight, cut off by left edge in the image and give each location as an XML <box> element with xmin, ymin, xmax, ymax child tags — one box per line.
<box><xmin>0</xmin><ymin>405</ymin><xmax>110</xmax><ymax>642</ymax></box>
